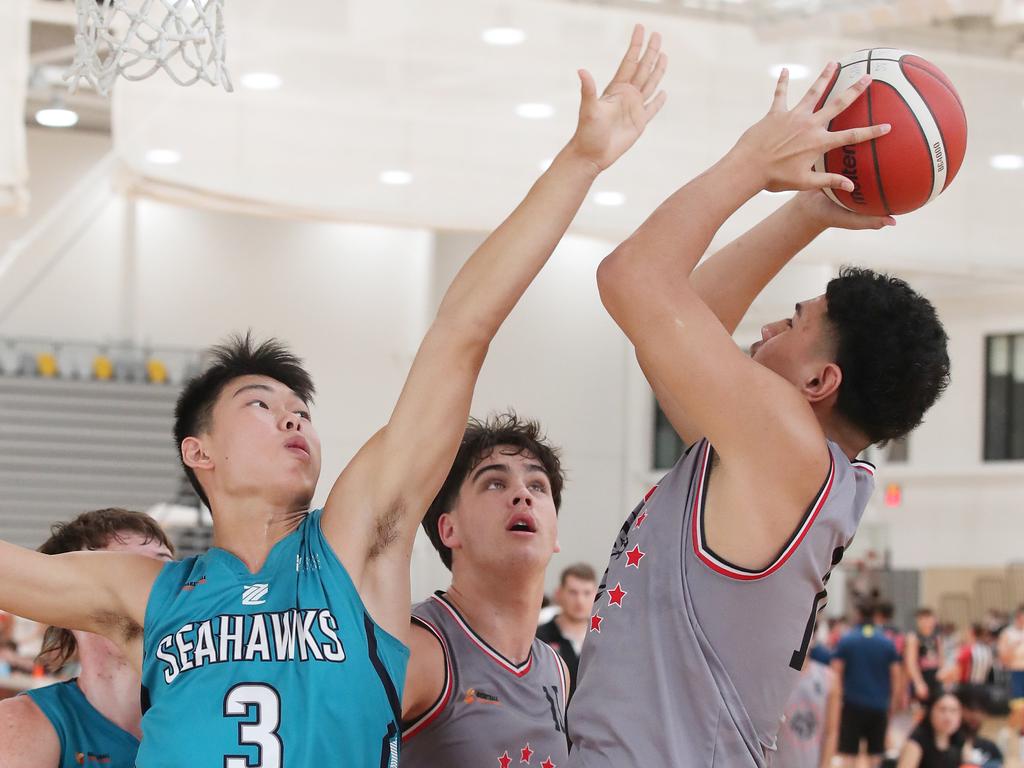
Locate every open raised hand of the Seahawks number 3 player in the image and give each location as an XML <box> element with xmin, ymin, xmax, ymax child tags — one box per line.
<box><xmin>569</xmin><ymin>25</ymin><xmax>669</xmax><ymax>171</ymax></box>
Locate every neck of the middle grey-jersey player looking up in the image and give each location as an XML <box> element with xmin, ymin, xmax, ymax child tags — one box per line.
<box><xmin>447</xmin><ymin>569</ymin><xmax>544</xmax><ymax>664</ymax></box>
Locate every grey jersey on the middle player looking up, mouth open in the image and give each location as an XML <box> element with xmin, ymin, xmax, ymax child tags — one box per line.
<box><xmin>399</xmin><ymin>592</ymin><xmax>568</xmax><ymax>768</ymax></box>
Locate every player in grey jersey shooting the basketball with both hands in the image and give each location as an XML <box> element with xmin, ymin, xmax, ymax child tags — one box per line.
<box><xmin>568</xmin><ymin>65</ymin><xmax>948</xmax><ymax>768</ymax></box>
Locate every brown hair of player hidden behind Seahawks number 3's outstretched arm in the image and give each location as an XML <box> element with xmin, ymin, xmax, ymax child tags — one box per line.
<box><xmin>36</xmin><ymin>507</ymin><xmax>174</xmax><ymax>671</ymax></box>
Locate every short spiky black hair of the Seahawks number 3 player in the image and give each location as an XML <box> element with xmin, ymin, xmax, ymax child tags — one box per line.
<box><xmin>174</xmin><ymin>332</ymin><xmax>315</xmax><ymax>507</ymax></box>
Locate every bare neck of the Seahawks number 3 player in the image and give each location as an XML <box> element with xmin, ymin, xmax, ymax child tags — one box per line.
<box><xmin>205</xmin><ymin>498</ymin><xmax>308</xmax><ymax>573</ymax></box>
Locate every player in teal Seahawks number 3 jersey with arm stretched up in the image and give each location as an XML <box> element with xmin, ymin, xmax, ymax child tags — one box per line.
<box><xmin>0</xmin><ymin>28</ymin><xmax>665</xmax><ymax>768</ymax></box>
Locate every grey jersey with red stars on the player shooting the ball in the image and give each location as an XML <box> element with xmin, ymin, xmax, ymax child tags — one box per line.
<box><xmin>568</xmin><ymin>440</ymin><xmax>873</xmax><ymax>768</ymax></box>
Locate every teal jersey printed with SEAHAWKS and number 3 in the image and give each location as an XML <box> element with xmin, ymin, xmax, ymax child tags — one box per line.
<box><xmin>138</xmin><ymin>510</ymin><xmax>409</xmax><ymax>768</ymax></box>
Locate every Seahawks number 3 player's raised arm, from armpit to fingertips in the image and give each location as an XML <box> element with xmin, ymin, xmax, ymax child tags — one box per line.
<box><xmin>324</xmin><ymin>27</ymin><xmax>665</xmax><ymax>638</ymax></box>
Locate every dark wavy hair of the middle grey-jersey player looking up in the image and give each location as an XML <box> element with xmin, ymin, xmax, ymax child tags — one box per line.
<box><xmin>423</xmin><ymin>411</ymin><xmax>565</xmax><ymax>570</ymax></box>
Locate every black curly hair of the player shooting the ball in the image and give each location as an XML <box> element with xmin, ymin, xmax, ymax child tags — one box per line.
<box><xmin>825</xmin><ymin>267</ymin><xmax>949</xmax><ymax>443</ymax></box>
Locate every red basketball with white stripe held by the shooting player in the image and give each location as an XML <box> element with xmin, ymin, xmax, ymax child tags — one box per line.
<box><xmin>815</xmin><ymin>48</ymin><xmax>967</xmax><ymax>216</ymax></box>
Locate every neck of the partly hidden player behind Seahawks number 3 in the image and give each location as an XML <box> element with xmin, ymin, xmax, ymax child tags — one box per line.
<box><xmin>75</xmin><ymin>632</ymin><xmax>142</xmax><ymax>738</ymax></box>
